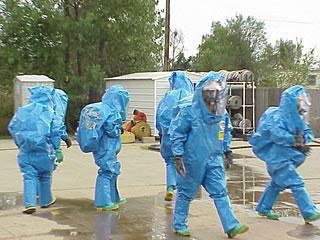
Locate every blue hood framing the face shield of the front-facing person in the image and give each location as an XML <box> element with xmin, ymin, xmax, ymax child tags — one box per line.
<box><xmin>192</xmin><ymin>72</ymin><xmax>228</xmax><ymax>123</ymax></box>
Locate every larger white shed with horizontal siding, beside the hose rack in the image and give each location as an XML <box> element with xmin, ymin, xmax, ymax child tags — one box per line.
<box><xmin>105</xmin><ymin>72</ymin><xmax>203</xmax><ymax>135</ymax></box>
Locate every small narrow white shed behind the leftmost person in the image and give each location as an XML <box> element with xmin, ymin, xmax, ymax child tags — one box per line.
<box><xmin>13</xmin><ymin>75</ymin><xmax>55</xmax><ymax>111</ymax></box>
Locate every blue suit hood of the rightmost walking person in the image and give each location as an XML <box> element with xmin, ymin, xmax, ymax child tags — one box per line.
<box><xmin>279</xmin><ymin>85</ymin><xmax>306</xmax><ymax>134</ymax></box>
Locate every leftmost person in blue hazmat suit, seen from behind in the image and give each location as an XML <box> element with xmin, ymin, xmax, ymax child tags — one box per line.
<box><xmin>8</xmin><ymin>86</ymin><xmax>68</xmax><ymax>214</ymax></box>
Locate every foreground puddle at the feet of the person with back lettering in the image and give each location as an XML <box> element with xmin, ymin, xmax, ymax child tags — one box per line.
<box><xmin>35</xmin><ymin>193</ymin><xmax>197</xmax><ymax>240</ymax></box>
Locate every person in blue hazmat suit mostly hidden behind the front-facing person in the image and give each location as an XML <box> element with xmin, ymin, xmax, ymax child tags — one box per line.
<box><xmin>156</xmin><ymin>71</ymin><xmax>193</xmax><ymax>201</ymax></box>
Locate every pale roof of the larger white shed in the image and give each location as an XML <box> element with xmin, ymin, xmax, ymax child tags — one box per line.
<box><xmin>105</xmin><ymin>72</ymin><xmax>203</xmax><ymax>80</ymax></box>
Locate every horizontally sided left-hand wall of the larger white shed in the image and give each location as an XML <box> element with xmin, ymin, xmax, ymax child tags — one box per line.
<box><xmin>106</xmin><ymin>79</ymin><xmax>155</xmax><ymax>134</ymax></box>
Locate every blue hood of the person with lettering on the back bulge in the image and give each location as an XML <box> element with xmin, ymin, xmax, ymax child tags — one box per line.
<box><xmin>102</xmin><ymin>85</ymin><xmax>129</xmax><ymax>121</ymax></box>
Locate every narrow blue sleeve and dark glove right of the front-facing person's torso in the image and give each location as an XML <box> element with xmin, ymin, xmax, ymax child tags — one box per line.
<box><xmin>223</xmin><ymin>110</ymin><xmax>233</xmax><ymax>170</ymax></box>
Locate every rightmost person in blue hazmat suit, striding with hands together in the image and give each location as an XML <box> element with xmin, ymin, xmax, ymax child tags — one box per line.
<box><xmin>249</xmin><ymin>85</ymin><xmax>320</xmax><ymax>223</ymax></box>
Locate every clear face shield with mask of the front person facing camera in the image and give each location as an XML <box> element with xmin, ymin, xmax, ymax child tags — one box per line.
<box><xmin>202</xmin><ymin>80</ymin><xmax>228</xmax><ymax>115</ymax></box>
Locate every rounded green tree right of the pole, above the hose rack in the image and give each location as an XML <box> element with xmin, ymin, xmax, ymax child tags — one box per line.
<box><xmin>192</xmin><ymin>15</ymin><xmax>267</xmax><ymax>73</ymax></box>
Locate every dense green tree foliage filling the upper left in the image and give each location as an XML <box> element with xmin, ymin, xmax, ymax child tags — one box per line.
<box><xmin>0</xmin><ymin>0</ymin><xmax>163</xmax><ymax>131</ymax></box>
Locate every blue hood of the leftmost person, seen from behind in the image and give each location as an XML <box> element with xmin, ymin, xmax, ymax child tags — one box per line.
<box><xmin>28</xmin><ymin>86</ymin><xmax>55</xmax><ymax>109</ymax></box>
